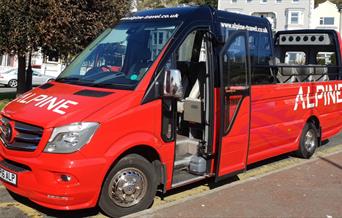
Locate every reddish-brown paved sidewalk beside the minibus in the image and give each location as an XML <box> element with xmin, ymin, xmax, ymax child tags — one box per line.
<box><xmin>130</xmin><ymin>152</ymin><xmax>342</xmax><ymax>218</ymax></box>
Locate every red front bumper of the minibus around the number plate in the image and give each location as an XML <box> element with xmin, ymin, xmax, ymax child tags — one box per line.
<box><xmin>0</xmin><ymin>146</ymin><xmax>106</xmax><ymax>210</ymax></box>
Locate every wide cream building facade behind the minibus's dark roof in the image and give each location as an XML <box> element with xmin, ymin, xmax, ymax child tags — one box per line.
<box><xmin>218</xmin><ymin>0</ymin><xmax>314</xmax><ymax>31</ymax></box>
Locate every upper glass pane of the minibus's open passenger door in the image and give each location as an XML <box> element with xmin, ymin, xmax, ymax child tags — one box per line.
<box><xmin>222</xmin><ymin>36</ymin><xmax>248</xmax><ymax>86</ymax></box>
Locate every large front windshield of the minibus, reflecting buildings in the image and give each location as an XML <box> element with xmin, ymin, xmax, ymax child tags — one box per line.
<box><xmin>56</xmin><ymin>22</ymin><xmax>177</xmax><ymax>90</ymax></box>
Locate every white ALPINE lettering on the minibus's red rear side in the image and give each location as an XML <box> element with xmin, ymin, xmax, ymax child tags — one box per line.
<box><xmin>294</xmin><ymin>84</ymin><xmax>342</xmax><ymax>111</ymax></box>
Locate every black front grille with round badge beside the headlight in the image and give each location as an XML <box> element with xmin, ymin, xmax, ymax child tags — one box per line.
<box><xmin>0</xmin><ymin>117</ymin><xmax>43</xmax><ymax>152</ymax></box>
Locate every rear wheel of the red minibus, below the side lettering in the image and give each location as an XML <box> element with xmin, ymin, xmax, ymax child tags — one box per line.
<box><xmin>296</xmin><ymin>123</ymin><xmax>318</xmax><ymax>159</ymax></box>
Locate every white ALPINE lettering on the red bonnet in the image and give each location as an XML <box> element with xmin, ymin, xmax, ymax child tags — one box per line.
<box><xmin>14</xmin><ymin>93</ymin><xmax>78</xmax><ymax>115</ymax></box>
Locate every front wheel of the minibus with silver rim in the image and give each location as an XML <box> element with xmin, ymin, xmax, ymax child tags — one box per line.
<box><xmin>99</xmin><ymin>154</ymin><xmax>157</xmax><ymax>217</ymax></box>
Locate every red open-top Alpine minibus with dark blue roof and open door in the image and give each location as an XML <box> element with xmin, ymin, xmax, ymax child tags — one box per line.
<box><xmin>0</xmin><ymin>6</ymin><xmax>342</xmax><ymax>217</ymax></box>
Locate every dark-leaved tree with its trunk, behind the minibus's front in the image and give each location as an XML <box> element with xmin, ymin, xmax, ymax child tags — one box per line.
<box><xmin>0</xmin><ymin>0</ymin><xmax>131</xmax><ymax>94</ymax></box>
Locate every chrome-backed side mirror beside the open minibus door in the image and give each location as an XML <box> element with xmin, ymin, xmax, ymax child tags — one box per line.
<box><xmin>163</xmin><ymin>69</ymin><xmax>184</xmax><ymax>98</ymax></box>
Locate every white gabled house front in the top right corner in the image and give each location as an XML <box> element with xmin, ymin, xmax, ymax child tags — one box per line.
<box><xmin>311</xmin><ymin>1</ymin><xmax>340</xmax><ymax>31</ymax></box>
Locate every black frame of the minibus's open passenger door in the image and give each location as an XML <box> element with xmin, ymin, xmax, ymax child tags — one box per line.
<box><xmin>215</xmin><ymin>30</ymin><xmax>252</xmax><ymax>182</ymax></box>
